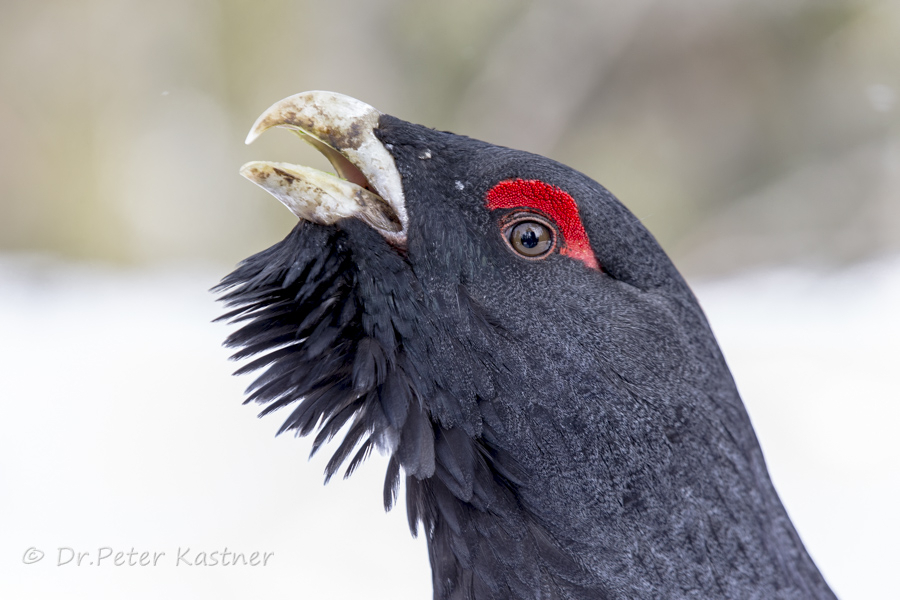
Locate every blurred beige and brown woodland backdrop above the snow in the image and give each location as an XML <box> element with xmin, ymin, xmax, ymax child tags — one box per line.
<box><xmin>0</xmin><ymin>0</ymin><xmax>900</xmax><ymax>274</ymax></box>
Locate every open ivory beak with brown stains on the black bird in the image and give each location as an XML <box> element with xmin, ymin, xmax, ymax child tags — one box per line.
<box><xmin>241</xmin><ymin>91</ymin><xmax>407</xmax><ymax>247</ymax></box>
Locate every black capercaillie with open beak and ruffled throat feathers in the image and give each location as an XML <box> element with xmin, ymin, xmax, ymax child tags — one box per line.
<box><xmin>215</xmin><ymin>91</ymin><xmax>835</xmax><ymax>600</ymax></box>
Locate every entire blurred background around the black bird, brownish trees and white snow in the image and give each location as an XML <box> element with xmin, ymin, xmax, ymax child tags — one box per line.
<box><xmin>0</xmin><ymin>0</ymin><xmax>900</xmax><ymax>598</ymax></box>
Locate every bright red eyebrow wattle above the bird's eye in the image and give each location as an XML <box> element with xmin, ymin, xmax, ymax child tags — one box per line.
<box><xmin>484</xmin><ymin>179</ymin><xmax>600</xmax><ymax>271</ymax></box>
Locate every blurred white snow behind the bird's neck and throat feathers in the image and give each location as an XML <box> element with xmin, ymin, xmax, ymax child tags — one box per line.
<box><xmin>0</xmin><ymin>257</ymin><xmax>900</xmax><ymax>600</ymax></box>
